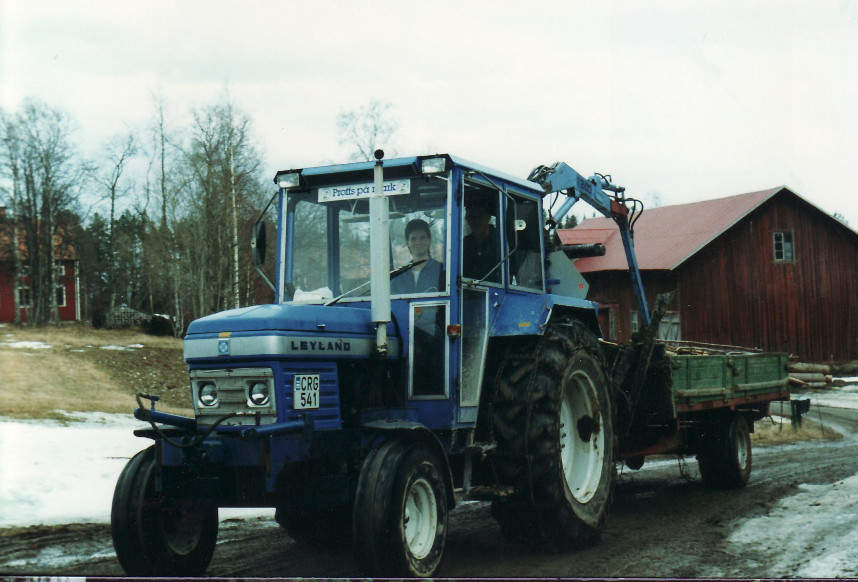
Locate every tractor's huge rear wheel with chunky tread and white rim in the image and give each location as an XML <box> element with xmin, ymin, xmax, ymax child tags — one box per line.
<box><xmin>492</xmin><ymin>321</ymin><xmax>615</xmax><ymax>550</ymax></box>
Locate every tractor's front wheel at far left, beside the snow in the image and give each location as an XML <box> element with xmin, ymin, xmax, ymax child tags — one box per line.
<box><xmin>110</xmin><ymin>447</ymin><xmax>218</xmax><ymax>576</ymax></box>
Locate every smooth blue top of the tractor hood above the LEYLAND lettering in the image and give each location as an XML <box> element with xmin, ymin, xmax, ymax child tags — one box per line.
<box><xmin>188</xmin><ymin>303</ymin><xmax>382</xmax><ymax>335</ymax></box>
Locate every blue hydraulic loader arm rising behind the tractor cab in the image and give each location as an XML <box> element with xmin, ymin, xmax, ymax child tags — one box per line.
<box><xmin>528</xmin><ymin>162</ymin><xmax>652</xmax><ymax>326</ymax></box>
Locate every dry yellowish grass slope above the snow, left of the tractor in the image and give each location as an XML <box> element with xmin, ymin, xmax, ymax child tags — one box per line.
<box><xmin>0</xmin><ymin>325</ymin><xmax>191</xmax><ymax>419</ymax></box>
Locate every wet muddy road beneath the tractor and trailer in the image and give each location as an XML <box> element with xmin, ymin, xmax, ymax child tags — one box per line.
<box><xmin>0</xmin><ymin>407</ymin><xmax>858</xmax><ymax>578</ymax></box>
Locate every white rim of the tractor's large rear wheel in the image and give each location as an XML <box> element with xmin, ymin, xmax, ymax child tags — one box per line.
<box><xmin>560</xmin><ymin>370</ymin><xmax>605</xmax><ymax>503</ymax></box>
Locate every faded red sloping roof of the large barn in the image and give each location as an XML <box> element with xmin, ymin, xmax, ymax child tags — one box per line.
<box><xmin>557</xmin><ymin>186</ymin><xmax>844</xmax><ymax>273</ymax></box>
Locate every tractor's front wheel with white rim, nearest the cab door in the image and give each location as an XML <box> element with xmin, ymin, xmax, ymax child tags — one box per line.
<box><xmin>353</xmin><ymin>440</ymin><xmax>447</xmax><ymax>577</ymax></box>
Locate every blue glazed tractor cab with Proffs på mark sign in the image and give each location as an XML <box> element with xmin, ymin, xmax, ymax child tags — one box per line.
<box><xmin>275</xmin><ymin>155</ymin><xmax>580</xmax><ymax>429</ymax></box>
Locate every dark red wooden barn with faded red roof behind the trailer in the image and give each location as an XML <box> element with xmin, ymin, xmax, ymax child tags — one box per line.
<box><xmin>558</xmin><ymin>187</ymin><xmax>858</xmax><ymax>362</ymax></box>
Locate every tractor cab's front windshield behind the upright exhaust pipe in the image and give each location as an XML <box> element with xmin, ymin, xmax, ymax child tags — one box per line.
<box><xmin>286</xmin><ymin>177</ymin><xmax>449</xmax><ymax>301</ymax></box>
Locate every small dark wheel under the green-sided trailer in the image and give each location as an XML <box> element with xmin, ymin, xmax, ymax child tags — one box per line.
<box><xmin>697</xmin><ymin>414</ymin><xmax>752</xmax><ymax>489</ymax></box>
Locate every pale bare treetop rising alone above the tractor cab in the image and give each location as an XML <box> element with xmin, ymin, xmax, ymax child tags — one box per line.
<box><xmin>337</xmin><ymin>99</ymin><xmax>399</xmax><ymax>162</ymax></box>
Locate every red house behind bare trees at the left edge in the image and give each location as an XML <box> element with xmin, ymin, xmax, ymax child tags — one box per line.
<box><xmin>0</xmin><ymin>207</ymin><xmax>80</xmax><ymax>323</ymax></box>
